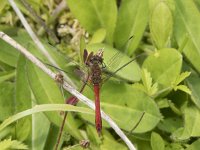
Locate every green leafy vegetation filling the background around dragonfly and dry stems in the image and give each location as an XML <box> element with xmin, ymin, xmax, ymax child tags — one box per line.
<box><xmin>0</xmin><ymin>0</ymin><xmax>200</xmax><ymax>150</ymax></box>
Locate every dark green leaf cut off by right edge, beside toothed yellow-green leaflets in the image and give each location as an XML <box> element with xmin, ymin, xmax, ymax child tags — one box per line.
<box><xmin>186</xmin><ymin>75</ymin><xmax>200</xmax><ymax>108</ymax></box>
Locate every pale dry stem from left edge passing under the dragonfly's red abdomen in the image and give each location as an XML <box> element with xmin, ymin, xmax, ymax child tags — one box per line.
<box><xmin>0</xmin><ymin>31</ymin><xmax>136</xmax><ymax>150</ymax></box>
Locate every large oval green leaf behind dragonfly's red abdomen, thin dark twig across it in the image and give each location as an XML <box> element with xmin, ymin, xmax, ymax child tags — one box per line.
<box><xmin>81</xmin><ymin>81</ymin><xmax>161</xmax><ymax>133</ymax></box>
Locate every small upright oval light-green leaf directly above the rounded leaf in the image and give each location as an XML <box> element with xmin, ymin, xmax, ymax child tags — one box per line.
<box><xmin>150</xmin><ymin>2</ymin><xmax>173</xmax><ymax>49</ymax></box>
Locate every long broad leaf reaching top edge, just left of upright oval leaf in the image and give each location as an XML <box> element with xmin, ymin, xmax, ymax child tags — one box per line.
<box><xmin>114</xmin><ymin>0</ymin><xmax>149</xmax><ymax>55</ymax></box>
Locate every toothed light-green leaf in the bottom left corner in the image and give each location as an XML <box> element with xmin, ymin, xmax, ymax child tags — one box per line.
<box><xmin>0</xmin><ymin>139</ymin><xmax>28</xmax><ymax>150</ymax></box>
